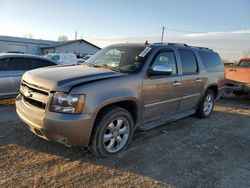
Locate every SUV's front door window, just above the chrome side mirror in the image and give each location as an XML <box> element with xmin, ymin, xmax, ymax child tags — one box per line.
<box><xmin>151</xmin><ymin>51</ymin><xmax>177</xmax><ymax>74</ymax></box>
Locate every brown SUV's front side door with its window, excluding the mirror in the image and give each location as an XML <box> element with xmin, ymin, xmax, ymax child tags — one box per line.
<box><xmin>143</xmin><ymin>50</ymin><xmax>181</xmax><ymax>123</ymax></box>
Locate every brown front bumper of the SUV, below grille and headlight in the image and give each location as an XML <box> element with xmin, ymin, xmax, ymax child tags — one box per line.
<box><xmin>16</xmin><ymin>97</ymin><xmax>94</xmax><ymax>146</ymax></box>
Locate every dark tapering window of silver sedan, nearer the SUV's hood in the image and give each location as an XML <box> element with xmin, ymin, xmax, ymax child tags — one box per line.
<box><xmin>23</xmin><ymin>58</ymin><xmax>55</xmax><ymax>70</ymax></box>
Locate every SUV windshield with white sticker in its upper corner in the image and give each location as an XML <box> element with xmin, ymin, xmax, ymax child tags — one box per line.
<box><xmin>85</xmin><ymin>46</ymin><xmax>151</xmax><ymax>73</ymax></box>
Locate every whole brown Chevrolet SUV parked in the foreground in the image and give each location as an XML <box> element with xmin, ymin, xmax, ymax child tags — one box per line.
<box><xmin>16</xmin><ymin>43</ymin><xmax>225</xmax><ymax>157</ymax></box>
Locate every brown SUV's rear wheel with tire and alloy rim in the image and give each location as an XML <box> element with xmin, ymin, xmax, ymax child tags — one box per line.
<box><xmin>195</xmin><ymin>89</ymin><xmax>215</xmax><ymax>118</ymax></box>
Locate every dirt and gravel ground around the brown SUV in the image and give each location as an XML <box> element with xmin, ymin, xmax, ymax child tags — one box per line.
<box><xmin>0</xmin><ymin>96</ymin><xmax>250</xmax><ymax>188</ymax></box>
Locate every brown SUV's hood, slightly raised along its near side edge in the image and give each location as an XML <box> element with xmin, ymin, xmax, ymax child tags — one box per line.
<box><xmin>22</xmin><ymin>65</ymin><xmax>126</xmax><ymax>92</ymax></box>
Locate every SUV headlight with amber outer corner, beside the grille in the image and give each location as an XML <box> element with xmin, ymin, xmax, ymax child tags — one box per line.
<box><xmin>50</xmin><ymin>92</ymin><xmax>84</xmax><ymax>114</ymax></box>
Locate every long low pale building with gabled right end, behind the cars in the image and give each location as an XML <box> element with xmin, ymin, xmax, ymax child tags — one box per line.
<box><xmin>0</xmin><ymin>36</ymin><xmax>100</xmax><ymax>56</ymax></box>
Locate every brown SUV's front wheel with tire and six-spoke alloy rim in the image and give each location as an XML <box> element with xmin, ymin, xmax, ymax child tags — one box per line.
<box><xmin>89</xmin><ymin>106</ymin><xmax>134</xmax><ymax>157</ymax></box>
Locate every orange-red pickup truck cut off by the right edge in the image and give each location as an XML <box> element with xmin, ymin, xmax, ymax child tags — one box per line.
<box><xmin>225</xmin><ymin>58</ymin><xmax>250</xmax><ymax>96</ymax></box>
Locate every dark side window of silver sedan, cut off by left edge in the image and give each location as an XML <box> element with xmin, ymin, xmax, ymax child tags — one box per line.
<box><xmin>0</xmin><ymin>58</ymin><xmax>24</xmax><ymax>71</ymax></box>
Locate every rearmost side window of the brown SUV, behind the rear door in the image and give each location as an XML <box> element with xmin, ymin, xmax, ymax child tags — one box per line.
<box><xmin>199</xmin><ymin>51</ymin><xmax>224</xmax><ymax>72</ymax></box>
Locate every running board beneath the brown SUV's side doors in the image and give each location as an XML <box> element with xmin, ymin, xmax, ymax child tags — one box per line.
<box><xmin>138</xmin><ymin>109</ymin><xmax>195</xmax><ymax>131</ymax></box>
